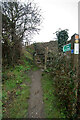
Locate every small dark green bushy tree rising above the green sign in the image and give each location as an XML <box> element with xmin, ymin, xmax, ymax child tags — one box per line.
<box><xmin>56</xmin><ymin>29</ymin><xmax>69</xmax><ymax>51</ymax></box>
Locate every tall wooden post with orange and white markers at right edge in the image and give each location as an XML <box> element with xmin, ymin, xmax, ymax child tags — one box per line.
<box><xmin>71</xmin><ymin>34</ymin><xmax>80</xmax><ymax>117</ymax></box>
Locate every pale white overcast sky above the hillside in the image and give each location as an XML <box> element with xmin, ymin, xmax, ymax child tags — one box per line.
<box><xmin>21</xmin><ymin>0</ymin><xmax>79</xmax><ymax>42</ymax></box>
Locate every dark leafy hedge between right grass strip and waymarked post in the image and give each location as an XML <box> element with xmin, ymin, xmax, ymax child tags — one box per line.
<box><xmin>47</xmin><ymin>55</ymin><xmax>76</xmax><ymax>118</ymax></box>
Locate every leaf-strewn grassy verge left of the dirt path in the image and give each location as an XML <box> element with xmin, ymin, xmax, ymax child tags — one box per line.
<box><xmin>2</xmin><ymin>60</ymin><xmax>32</xmax><ymax>118</ymax></box>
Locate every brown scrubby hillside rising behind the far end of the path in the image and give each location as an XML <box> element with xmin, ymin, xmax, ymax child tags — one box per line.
<box><xmin>32</xmin><ymin>41</ymin><xmax>58</xmax><ymax>64</ymax></box>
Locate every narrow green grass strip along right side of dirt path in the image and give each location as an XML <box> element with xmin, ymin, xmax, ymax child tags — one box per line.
<box><xmin>42</xmin><ymin>72</ymin><xmax>65</xmax><ymax>118</ymax></box>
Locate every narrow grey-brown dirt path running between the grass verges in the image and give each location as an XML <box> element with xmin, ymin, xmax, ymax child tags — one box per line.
<box><xmin>28</xmin><ymin>70</ymin><xmax>44</xmax><ymax>118</ymax></box>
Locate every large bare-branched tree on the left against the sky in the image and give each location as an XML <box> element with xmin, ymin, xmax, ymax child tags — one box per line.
<box><xmin>2</xmin><ymin>1</ymin><xmax>41</xmax><ymax>63</ymax></box>
